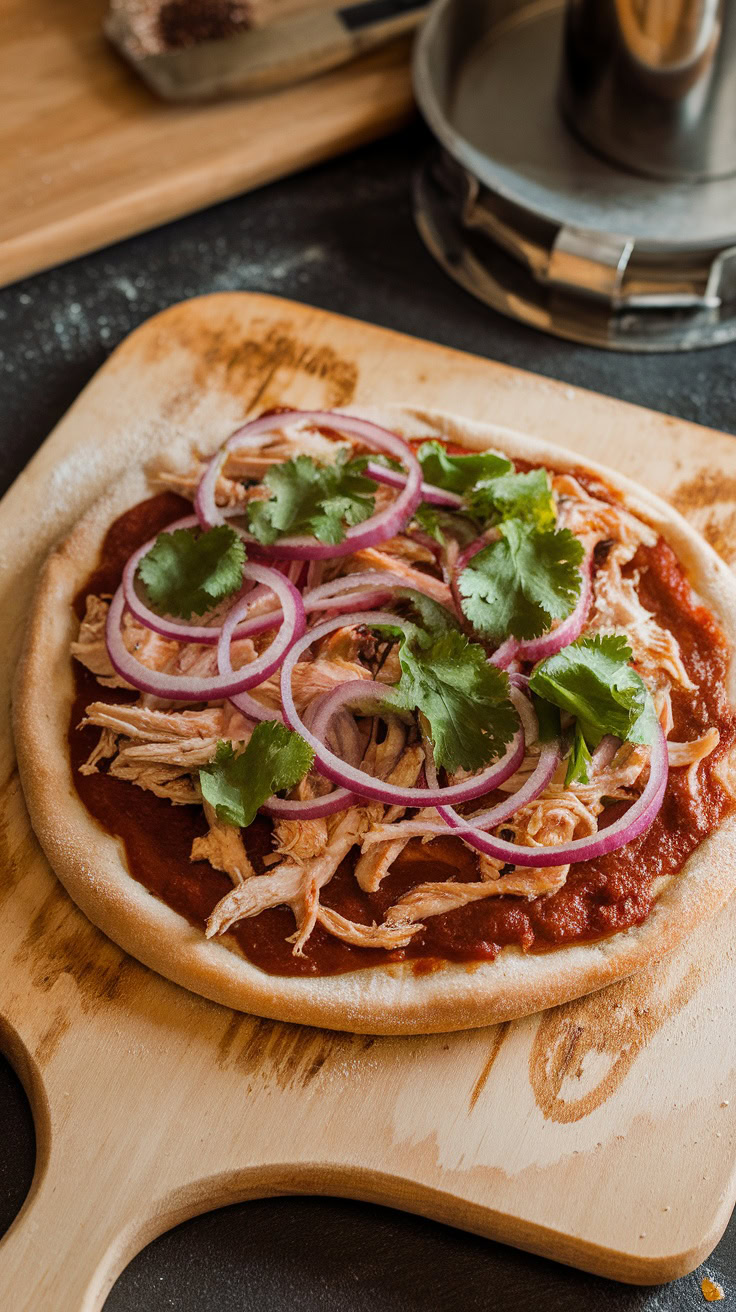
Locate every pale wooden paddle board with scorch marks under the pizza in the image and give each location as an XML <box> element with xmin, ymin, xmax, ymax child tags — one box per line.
<box><xmin>0</xmin><ymin>294</ymin><xmax>736</xmax><ymax>1312</ymax></box>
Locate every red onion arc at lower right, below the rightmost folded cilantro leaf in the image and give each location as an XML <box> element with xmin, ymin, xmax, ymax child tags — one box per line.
<box><xmin>426</xmin><ymin>723</ymin><xmax>668</xmax><ymax>869</ymax></box>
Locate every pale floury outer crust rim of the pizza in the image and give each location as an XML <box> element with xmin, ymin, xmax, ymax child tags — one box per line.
<box><xmin>13</xmin><ymin>407</ymin><xmax>736</xmax><ymax>1035</ymax></box>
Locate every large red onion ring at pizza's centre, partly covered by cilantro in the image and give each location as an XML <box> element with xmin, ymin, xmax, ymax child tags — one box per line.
<box><xmin>281</xmin><ymin>610</ymin><xmax>523</xmax><ymax>807</ymax></box>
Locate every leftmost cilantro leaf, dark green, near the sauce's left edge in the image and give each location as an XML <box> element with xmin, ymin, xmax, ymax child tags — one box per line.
<box><xmin>138</xmin><ymin>523</ymin><xmax>245</xmax><ymax>619</ymax></box>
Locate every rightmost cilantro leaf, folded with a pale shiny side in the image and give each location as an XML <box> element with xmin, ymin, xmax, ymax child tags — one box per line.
<box><xmin>530</xmin><ymin>634</ymin><xmax>656</xmax><ymax>748</ymax></box>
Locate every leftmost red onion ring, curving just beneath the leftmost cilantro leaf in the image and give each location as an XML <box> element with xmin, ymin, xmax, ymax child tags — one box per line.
<box><xmin>105</xmin><ymin>562</ymin><xmax>306</xmax><ymax>715</ymax></box>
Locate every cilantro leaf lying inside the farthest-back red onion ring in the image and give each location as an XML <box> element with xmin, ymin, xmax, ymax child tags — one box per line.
<box><xmin>248</xmin><ymin>447</ymin><xmax>375</xmax><ymax>546</ymax></box>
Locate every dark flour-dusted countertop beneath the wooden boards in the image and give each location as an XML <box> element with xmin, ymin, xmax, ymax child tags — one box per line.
<box><xmin>0</xmin><ymin>127</ymin><xmax>736</xmax><ymax>1312</ymax></box>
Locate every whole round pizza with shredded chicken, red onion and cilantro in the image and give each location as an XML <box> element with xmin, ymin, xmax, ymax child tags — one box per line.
<box><xmin>14</xmin><ymin>407</ymin><xmax>736</xmax><ymax>1034</ymax></box>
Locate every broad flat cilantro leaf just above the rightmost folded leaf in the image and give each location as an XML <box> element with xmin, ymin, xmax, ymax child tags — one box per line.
<box><xmin>459</xmin><ymin>520</ymin><xmax>583</xmax><ymax>643</ymax></box>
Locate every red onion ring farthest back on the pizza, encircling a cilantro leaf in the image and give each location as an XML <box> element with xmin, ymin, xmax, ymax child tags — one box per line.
<box><xmin>194</xmin><ymin>411</ymin><xmax>421</xmax><ymax>560</ymax></box>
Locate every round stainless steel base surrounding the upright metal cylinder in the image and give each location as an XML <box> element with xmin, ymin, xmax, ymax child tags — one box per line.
<box><xmin>415</xmin><ymin>0</ymin><xmax>736</xmax><ymax>350</ymax></box>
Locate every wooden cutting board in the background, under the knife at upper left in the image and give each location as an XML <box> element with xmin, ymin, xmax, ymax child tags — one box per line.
<box><xmin>0</xmin><ymin>0</ymin><xmax>412</xmax><ymax>286</ymax></box>
